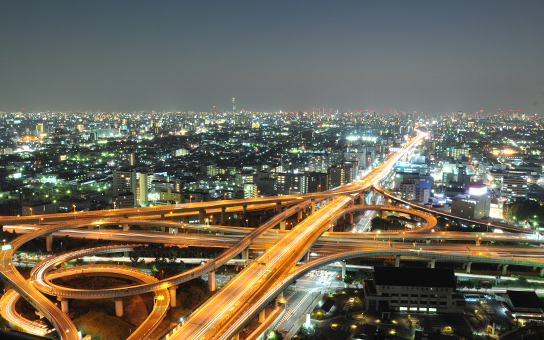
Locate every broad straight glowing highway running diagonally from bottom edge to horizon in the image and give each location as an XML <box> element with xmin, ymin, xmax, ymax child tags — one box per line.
<box><xmin>166</xmin><ymin>135</ymin><xmax>424</xmax><ymax>340</ymax></box>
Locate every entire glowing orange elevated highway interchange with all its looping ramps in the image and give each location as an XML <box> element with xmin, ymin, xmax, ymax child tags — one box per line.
<box><xmin>0</xmin><ymin>134</ymin><xmax>544</xmax><ymax>340</ymax></box>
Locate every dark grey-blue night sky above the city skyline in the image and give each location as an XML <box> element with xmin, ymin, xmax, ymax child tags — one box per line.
<box><xmin>0</xmin><ymin>0</ymin><xmax>544</xmax><ymax>114</ymax></box>
